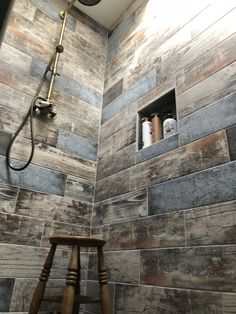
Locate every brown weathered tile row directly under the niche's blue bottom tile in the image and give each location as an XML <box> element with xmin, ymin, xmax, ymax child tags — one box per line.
<box><xmin>95</xmin><ymin>131</ymin><xmax>229</xmax><ymax>202</ymax></box>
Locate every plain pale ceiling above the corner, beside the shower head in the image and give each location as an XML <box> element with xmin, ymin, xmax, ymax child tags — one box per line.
<box><xmin>75</xmin><ymin>0</ymin><xmax>135</xmax><ymax>30</ymax></box>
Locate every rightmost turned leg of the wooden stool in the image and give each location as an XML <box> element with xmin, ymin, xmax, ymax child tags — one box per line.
<box><xmin>98</xmin><ymin>247</ymin><xmax>112</xmax><ymax>314</ymax></box>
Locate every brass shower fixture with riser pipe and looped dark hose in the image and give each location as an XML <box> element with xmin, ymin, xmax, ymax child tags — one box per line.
<box><xmin>6</xmin><ymin>0</ymin><xmax>101</xmax><ymax>171</ymax></box>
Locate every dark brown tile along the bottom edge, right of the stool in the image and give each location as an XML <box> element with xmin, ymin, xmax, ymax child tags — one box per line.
<box><xmin>115</xmin><ymin>284</ymin><xmax>227</xmax><ymax>314</ymax></box>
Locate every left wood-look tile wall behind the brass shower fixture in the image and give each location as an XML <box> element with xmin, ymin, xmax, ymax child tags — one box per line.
<box><xmin>0</xmin><ymin>0</ymin><xmax>107</xmax><ymax>313</ymax></box>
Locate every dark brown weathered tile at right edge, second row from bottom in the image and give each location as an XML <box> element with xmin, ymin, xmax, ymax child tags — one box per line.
<box><xmin>140</xmin><ymin>245</ymin><xmax>236</xmax><ymax>292</ymax></box>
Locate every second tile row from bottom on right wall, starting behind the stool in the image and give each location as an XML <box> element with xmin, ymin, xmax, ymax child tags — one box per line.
<box><xmin>88</xmin><ymin>245</ymin><xmax>236</xmax><ymax>292</ymax></box>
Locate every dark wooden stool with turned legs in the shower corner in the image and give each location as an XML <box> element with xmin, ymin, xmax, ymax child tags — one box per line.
<box><xmin>29</xmin><ymin>236</ymin><xmax>112</xmax><ymax>314</ymax></box>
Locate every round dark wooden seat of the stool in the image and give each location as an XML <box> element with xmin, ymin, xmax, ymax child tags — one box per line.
<box><xmin>49</xmin><ymin>236</ymin><xmax>106</xmax><ymax>247</ymax></box>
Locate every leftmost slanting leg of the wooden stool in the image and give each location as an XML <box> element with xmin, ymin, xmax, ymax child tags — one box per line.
<box><xmin>29</xmin><ymin>244</ymin><xmax>57</xmax><ymax>314</ymax></box>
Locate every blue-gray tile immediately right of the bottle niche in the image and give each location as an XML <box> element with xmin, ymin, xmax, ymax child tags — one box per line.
<box><xmin>179</xmin><ymin>92</ymin><xmax>236</xmax><ymax>145</ymax></box>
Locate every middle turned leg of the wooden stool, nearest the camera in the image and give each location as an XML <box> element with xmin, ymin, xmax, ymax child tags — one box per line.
<box><xmin>61</xmin><ymin>245</ymin><xmax>78</xmax><ymax>314</ymax></box>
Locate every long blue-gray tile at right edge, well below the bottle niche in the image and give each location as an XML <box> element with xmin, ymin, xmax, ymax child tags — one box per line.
<box><xmin>148</xmin><ymin>161</ymin><xmax>236</xmax><ymax>215</ymax></box>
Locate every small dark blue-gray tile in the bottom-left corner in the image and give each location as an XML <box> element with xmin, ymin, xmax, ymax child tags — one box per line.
<box><xmin>0</xmin><ymin>278</ymin><xmax>15</xmax><ymax>312</ymax></box>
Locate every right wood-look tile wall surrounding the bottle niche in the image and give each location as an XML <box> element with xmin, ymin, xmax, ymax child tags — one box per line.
<box><xmin>91</xmin><ymin>0</ymin><xmax>236</xmax><ymax>314</ymax></box>
